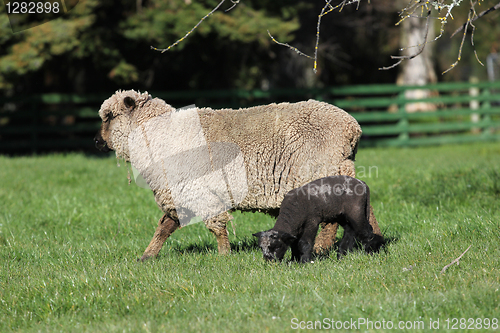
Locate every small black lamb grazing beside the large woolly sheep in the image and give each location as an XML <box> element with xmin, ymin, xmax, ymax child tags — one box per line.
<box><xmin>254</xmin><ymin>176</ymin><xmax>384</xmax><ymax>262</ymax></box>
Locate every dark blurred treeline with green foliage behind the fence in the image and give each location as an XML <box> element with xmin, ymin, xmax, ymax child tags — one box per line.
<box><xmin>0</xmin><ymin>0</ymin><xmax>500</xmax><ymax>96</ymax></box>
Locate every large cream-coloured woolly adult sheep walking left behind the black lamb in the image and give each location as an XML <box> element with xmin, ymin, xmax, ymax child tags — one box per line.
<box><xmin>95</xmin><ymin>90</ymin><xmax>380</xmax><ymax>260</ymax></box>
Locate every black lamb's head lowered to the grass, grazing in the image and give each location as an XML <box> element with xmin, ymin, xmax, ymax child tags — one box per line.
<box><xmin>253</xmin><ymin>229</ymin><xmax>296</xmax><ymax>261</ymax></box>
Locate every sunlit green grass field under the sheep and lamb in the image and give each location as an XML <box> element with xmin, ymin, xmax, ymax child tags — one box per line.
<box><xmin>0</xmin><ymin>144</ymin><xmax>500</xmax><ymax>332</ymax></box>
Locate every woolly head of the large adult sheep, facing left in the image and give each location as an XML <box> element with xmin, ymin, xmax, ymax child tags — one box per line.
<box><xmin>94</xmin><ymin>90</ymin><xmax>171</xmax><ymax>161</ymax></box>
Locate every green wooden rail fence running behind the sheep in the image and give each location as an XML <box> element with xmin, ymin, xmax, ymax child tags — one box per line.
<box><xmin>0</xmin><ymin>82</ymin><xmax>500</xmax><ymax>154</ymax></box>
